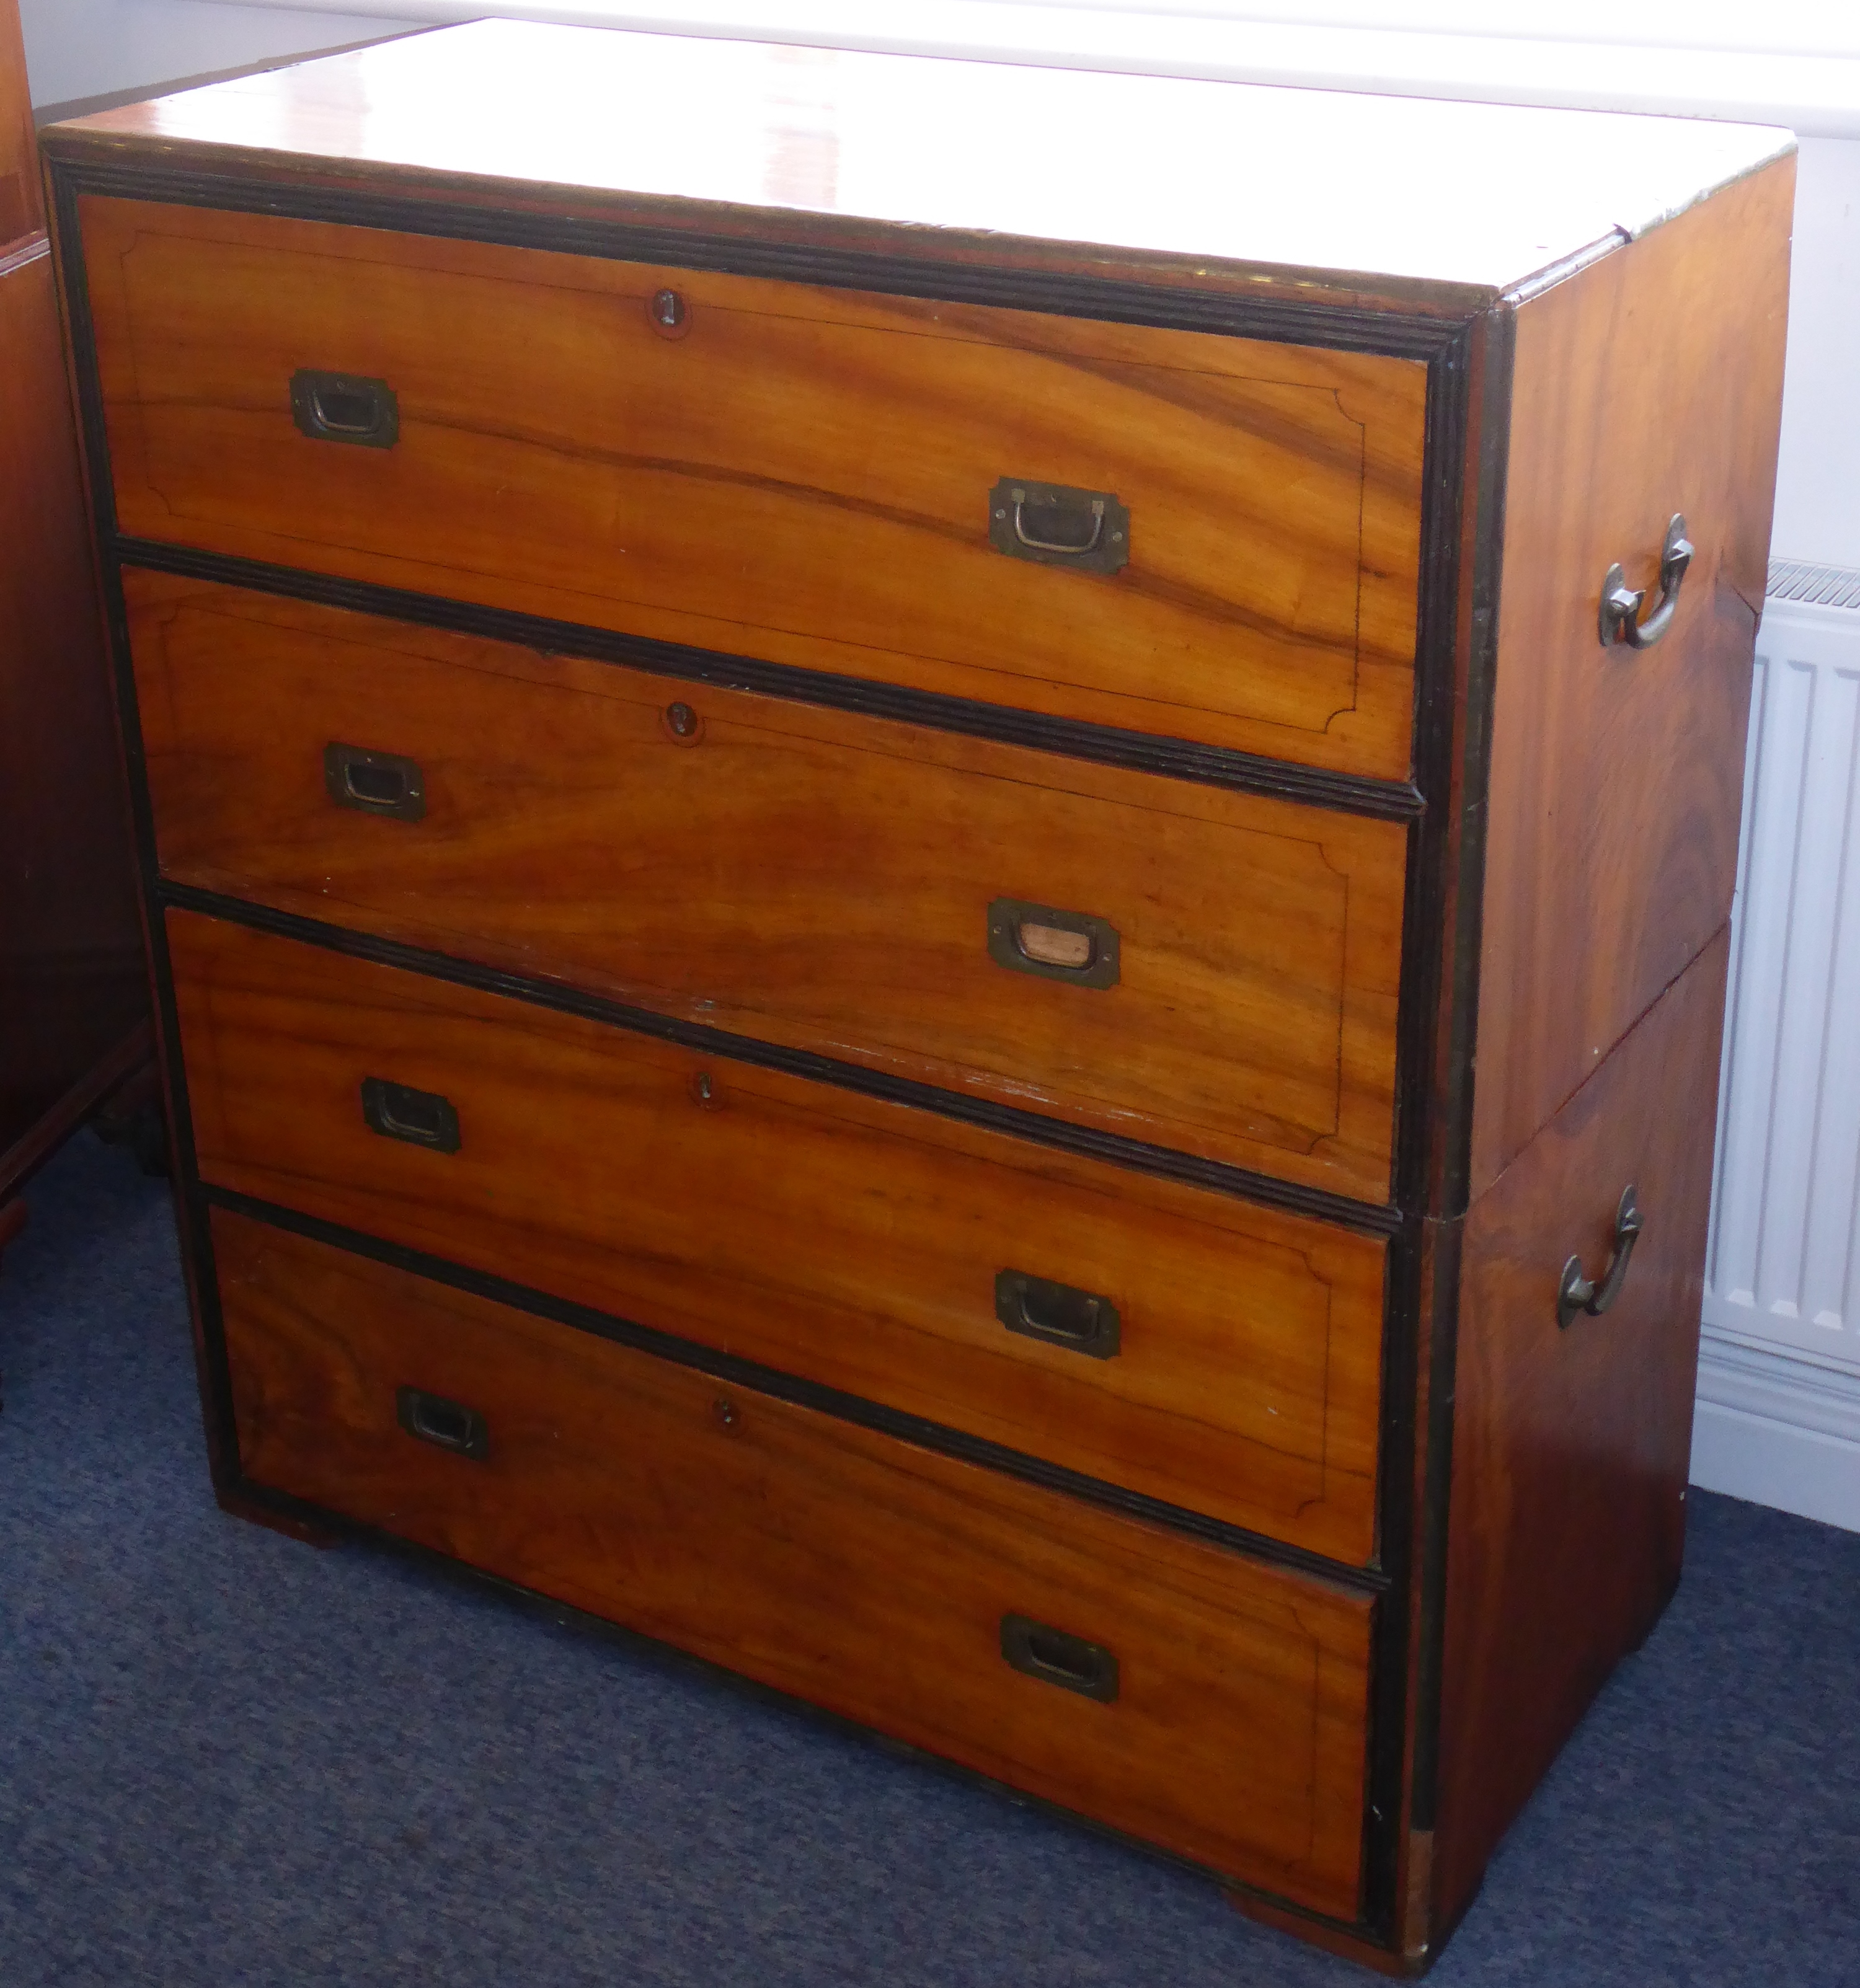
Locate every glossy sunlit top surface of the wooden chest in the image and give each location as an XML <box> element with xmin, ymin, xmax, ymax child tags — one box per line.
<box><xmin>46</xmin><ymin>20</ymin><xmax>1794</xmax><ymax>312</ymax></box>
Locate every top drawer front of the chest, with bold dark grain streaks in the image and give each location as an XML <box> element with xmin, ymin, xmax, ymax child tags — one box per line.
<box><xmin>84</xmin><ymin>197</ymin><xmax>1427</xmax><ymax>779</ymax></box>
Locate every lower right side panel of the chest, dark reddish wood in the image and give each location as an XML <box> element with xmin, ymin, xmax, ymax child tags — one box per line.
<box><xmin>1434</xmin><ymin>930</ymin><xmax>1727</xmax><ymax>1927</ymax></box>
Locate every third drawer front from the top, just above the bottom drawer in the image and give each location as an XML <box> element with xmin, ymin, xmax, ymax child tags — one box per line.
<box><xmin>167</xmin><ymin>912</ymin><xmax>1384</xmax><ymax>1563</ymax></box>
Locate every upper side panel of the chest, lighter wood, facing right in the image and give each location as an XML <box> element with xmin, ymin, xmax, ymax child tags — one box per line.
<box><xmin>1470</xmin><ymin>159</ymin><xmax>1794</xmax><ymax>1199</ymax></box>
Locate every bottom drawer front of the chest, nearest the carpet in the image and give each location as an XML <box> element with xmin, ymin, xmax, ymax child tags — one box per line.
<box><xmin>213</xmin><ymin>1211</ymin><xmax>1373</xmax><ymax>1919</ymax></box>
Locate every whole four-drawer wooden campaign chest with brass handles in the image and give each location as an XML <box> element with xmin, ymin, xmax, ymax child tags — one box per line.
<box><xmin>46</xmin><ymin>22</ymin><xmax>1792</xmax><ymax>1970</ymax></box>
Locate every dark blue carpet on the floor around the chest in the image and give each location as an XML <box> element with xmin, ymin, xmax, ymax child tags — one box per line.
<box><xmin>0</xmin><ymin>1135</ymin><xmax>1860</xmax><ymax>1988</ymax></box>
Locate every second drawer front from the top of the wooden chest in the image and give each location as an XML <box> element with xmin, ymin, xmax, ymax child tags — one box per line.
<box><xmin>127</xmin><ymin>573</ymin><xmax>1406</xmax><ymax>1203</ymax></box>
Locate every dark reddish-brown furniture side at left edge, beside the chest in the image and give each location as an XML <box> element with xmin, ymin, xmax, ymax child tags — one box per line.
<box><xmin>0</xmin><ymin>239</ymin><xmax>147</xmax><ymax>1195</ymax></box>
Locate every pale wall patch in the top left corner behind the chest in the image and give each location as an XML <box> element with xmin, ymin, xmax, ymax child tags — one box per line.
<box><xmin>20</xmin><ymin>0</ymin><xmax>412</xmax><ymax>104</ymax></box>
